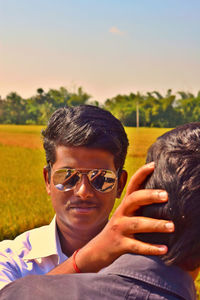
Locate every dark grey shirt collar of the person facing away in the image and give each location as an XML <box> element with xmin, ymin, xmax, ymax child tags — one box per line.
<box><xmin>100</xmin><ymin>254</ymin><xmax>196</xmax><ymax>300</ymax></box>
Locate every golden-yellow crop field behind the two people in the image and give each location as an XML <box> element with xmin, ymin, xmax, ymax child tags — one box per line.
<box><xmin>0</xmin><ymin>125</ymin><xmax>200</xmax><ymax>296</ymax></box>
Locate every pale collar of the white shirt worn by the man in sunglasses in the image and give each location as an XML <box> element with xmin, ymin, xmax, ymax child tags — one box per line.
<box><xmin>24</xmin><ymin>216</ymin><xmax>67</xmax><ymax>264</ymax></box>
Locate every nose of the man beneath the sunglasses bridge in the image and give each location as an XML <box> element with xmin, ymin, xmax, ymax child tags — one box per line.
<box><xmin>74</xmin><ymin>174</ymin><xmax>94</xmax><ymax>200</ymax></box>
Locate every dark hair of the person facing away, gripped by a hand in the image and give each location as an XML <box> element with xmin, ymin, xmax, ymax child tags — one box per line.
<box><xmin>138</xmin><ymin>123</ymin><xmax>200</xmax><ymax>271</ymax></box>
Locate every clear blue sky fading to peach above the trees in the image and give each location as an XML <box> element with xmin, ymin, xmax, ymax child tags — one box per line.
<box><xmin>0</xmin><ymin>0</ymin><xmax>200</xmax><ymax>101</ymax></box>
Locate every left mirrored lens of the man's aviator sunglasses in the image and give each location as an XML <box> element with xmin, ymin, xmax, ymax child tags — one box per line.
<box><xmin>53</xmin><ymin>169</ymin><xmax>80</xmax><ymax>191</ymax></box>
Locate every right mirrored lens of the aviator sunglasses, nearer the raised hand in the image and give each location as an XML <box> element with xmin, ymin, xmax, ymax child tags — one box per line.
<box><xmin>88</xmin><ymin>170</ymin><xmax>117</xmax><ymax>192</ymax></box>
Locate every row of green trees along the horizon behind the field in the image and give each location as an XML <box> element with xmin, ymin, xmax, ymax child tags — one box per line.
<box><xmin>0</xmin><ymin>87</ymin><xmax>200</xmax><ymax>127</ymax></box>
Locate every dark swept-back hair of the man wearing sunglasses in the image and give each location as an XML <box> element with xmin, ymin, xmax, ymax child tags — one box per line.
<box><xmin>42</xmin><ymin>105</ymin><xmax>128</xmax><ymax>176</ymax></box>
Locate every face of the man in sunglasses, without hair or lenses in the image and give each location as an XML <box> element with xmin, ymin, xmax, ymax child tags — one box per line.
<box><xmin>45</xmin><ymin>146</ymin><xmax>125</xmax><ymax>234</ymax></box>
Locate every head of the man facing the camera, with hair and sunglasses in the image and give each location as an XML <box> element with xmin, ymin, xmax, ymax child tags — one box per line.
<box><xmin>43</xmin><ymin>105</ymin><xmax>128</xmax><ymax>246</ymax></box>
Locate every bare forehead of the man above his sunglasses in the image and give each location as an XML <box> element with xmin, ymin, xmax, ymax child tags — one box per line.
<box><xmin>53</xmin><ymin>146</ymin><xmax>116</xmax><ymax>171</ymax></box>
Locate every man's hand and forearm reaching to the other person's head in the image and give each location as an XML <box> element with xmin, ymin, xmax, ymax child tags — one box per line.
<box><xmin>47</xmin><ymin>163</ymin><xmax>174</xmax><ymax>275</ymax></box>
